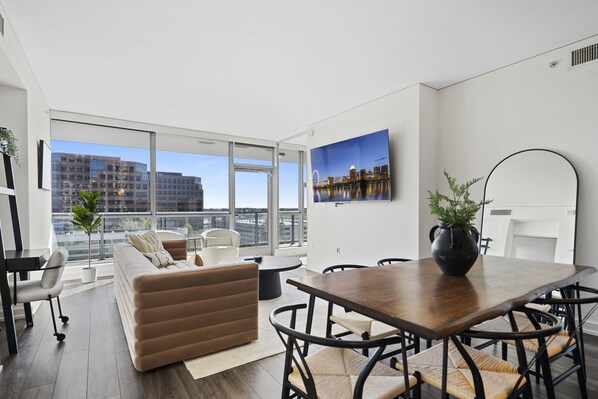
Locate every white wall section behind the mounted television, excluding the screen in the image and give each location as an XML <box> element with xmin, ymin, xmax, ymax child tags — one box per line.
<box><xmin>307</xmin><ymin>85</ymin><xmax>436</xmax><ymax>270</ymax></box>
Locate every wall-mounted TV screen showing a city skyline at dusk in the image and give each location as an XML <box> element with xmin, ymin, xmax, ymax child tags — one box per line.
<box><xmin>310</xmin><ymin>129</ymin><xmax>391</xmax><ymax>202</ymax></box>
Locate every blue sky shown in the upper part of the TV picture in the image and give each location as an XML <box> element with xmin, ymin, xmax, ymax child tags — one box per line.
<box><xmin>311</xmin><ymin>130</ymin><xmax>389</xmax><ymax>180</ymax></box>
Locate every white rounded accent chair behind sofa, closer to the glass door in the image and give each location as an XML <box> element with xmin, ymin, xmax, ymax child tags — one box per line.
<box><xmin>199</xmin><ymin>229</ymin><xmax>241</xmax><ymax>266</ymax></box>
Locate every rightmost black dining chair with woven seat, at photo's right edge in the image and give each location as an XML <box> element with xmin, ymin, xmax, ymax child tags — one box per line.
<box><xmin>475</xmin><ymin>285</ymin><xmax>598</xmax><ymax>399</ymax></box>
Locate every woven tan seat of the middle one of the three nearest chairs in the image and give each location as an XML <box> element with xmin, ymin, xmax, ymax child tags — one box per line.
<box><xmin>395</xmin><ymin>341</ymin><xmax>526</xmax><ymax>399</ymax></box>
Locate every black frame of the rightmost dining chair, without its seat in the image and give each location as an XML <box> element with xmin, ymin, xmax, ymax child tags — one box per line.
<box><xmin>528</xmin><ymin>285</ymin><xmax>598</xmax><ymax>399</ymax></box>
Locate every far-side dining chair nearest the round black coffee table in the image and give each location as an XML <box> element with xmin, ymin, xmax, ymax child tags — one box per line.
<box><xmin>322</xmin><ymin>264</ymin><xmax>420</xmax><ymax>359</ymax></box>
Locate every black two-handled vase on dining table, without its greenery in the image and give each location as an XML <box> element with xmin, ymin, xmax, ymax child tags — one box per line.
<box><xmin>430</xmin><ymin>224</ymin><xmax>479</xmax><ymax>276</ymax></box>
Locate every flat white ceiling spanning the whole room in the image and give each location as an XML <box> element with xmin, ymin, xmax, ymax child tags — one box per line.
<box><xmin>0</xmin><ymin>0</ymin><xmax>598</xmax><ymax>140</ymax></box>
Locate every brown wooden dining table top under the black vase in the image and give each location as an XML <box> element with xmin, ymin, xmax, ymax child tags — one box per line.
<box><xmin>287</xmin><ymin>255</ymin><xmax>596</xmax><ymax>339</ymax></box>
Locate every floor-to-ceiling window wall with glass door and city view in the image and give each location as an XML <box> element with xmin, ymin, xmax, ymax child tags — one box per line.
<box><xmin>52</xmin><ymin>120</ymin><xmax>306</xmax><ymax>261</ymax></box>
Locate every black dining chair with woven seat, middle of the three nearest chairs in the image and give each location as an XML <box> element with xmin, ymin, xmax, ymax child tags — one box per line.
<box><xmin>391</xmin><ymin>308</ymin><xmax>562</xmax><ymax>399</ymax></box>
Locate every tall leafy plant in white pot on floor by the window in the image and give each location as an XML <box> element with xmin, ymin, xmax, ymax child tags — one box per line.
<box><xmin>71</xmin><ymin>191</ymin><xmax>102</xmax><ymax>283</ymax></box>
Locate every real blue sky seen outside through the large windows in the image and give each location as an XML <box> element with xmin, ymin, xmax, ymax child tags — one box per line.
<box><xmin>52</xmin><ymin>140</ymin><xmax>297</xmax><ymax>209</ymax></box>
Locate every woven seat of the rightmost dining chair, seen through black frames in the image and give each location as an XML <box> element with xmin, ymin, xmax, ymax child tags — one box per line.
<box><xmin>471</xmin><ymin>312</ymin><xmax>575</xmax><ymax>357</ymax></box>
